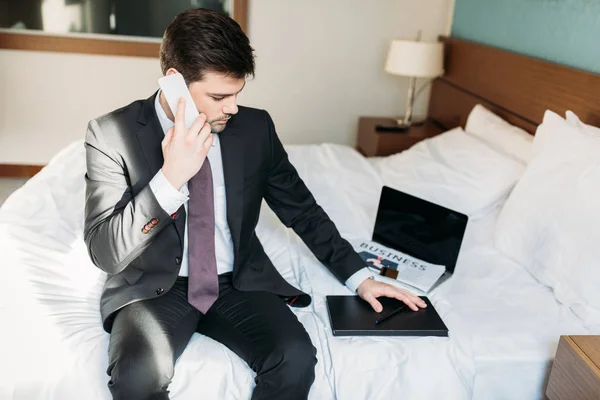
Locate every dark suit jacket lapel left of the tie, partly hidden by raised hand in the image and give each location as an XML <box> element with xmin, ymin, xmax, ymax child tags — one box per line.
<box><xmin>137</xmin><ymin>92</ymin><xmax>185</xmax><ymax>248</ymax></box>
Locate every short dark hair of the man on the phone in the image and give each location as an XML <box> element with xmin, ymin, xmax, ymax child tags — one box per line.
<box><xmin>160</xmin><ymin>8</ymin><xmax>254</xmax><ymax>85</ymax></box>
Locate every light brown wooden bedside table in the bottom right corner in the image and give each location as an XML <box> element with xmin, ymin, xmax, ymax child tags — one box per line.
<box><xmin>546</xmin><ymin>336</ymin><xmax>600</xmax><ymax>400</ymax></box>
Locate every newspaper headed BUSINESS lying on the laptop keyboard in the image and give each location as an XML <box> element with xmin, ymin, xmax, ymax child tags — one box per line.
<box><xmin>354</xmin><ymin>241</ymin><xmax>446</xmax><ymax>293</ymax></box>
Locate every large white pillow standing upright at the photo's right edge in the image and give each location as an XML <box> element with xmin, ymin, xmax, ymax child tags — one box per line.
<box><xmin>495</xmin><ymin>111</ymin><xmax>600</xmax><ymax>327</ymax></box>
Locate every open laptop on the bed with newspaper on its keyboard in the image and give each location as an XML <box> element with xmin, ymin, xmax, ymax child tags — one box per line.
<box><xmin>355</xmin><ymin>186</ymin><xmax>469</xmax><ymax>293</ymax></box>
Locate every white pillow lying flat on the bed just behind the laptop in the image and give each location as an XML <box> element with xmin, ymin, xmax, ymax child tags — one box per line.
<box><xmin>376</xmin><ymin>128</ymin><xmax>525</xmax><ymax>217</ymax></box>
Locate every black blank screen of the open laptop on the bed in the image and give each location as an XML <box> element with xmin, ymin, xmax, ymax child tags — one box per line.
<box><xmin>373</xmin><ymin>186</ymin><xmax>468</xmax><ymax>273</ymax></box>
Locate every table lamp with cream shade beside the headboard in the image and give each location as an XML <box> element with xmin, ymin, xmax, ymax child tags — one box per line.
<box><xmin>385</xmin><ymin>34</ymin><xmax>444</xmax><ymax>131</ymax></box>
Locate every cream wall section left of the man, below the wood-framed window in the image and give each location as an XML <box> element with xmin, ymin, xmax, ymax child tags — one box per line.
<box><xmin>0</xmin><ymin>50</ymin><xmax>160</xmax><ymax>164</ymax></box>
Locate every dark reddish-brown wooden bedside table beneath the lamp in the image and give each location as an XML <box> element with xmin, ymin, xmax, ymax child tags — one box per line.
<box><xmin>356</xmin><ymin>117</ymin><xmax>444</xmax><ymax>157</ymax></box>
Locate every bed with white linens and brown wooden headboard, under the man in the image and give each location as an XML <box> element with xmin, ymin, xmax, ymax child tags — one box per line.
<box><xmin>0</xmin><ymin>39</ymin><xmax>600</xmax><ymax>400</ymax></box>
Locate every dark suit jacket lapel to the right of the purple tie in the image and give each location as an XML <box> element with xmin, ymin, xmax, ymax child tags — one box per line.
<box><xmin>219</xmin><ymin>117</ymin><xmax>244</xmax><ymax>258</ymax></box>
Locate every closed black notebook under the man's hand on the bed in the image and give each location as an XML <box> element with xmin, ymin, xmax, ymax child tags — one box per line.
<box><xmin>327</xmin><ymin>296</ymin><xmax>448</xmax><ymax>336</ymax></box>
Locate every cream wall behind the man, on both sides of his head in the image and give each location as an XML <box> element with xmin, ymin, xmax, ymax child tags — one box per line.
<box><xmin>0</xmin><ymin>0</ymin><xmax>452</xmax><ymax>164</ymax></box>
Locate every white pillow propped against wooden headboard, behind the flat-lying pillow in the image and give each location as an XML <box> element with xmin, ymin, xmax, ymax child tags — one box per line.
<box><xmin>465</xmin><ymin>104</ymin><xmax>533</xmax><ymax>164</ymax></box>
